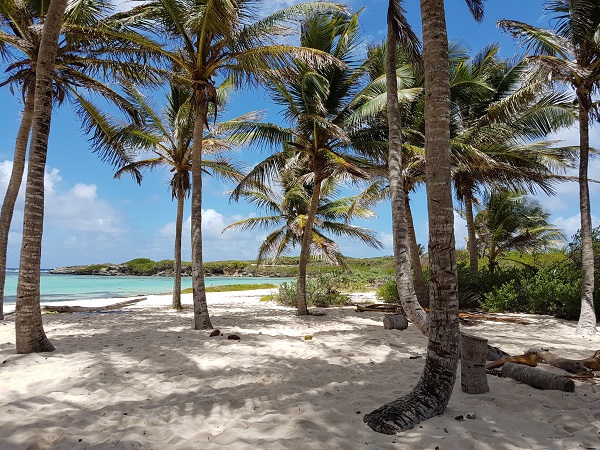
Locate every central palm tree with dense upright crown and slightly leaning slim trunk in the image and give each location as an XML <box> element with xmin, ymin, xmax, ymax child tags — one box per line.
<box><xmin>233</xmin><ymin>13</ymin><xmax>367</xmax><ymax>315</ymax></box>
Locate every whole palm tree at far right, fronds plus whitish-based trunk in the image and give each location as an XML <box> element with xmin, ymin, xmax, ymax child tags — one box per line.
<box><xmin>498</xmin><ymin>0</ymin><xmax>600</xmax><ymax>335</ymax></box>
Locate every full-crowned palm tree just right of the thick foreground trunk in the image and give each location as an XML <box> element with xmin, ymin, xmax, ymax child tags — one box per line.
<box><xmin>452</xmin><ymin>45</ymin><xmax>574</xmax><ymax>278</ymax></box>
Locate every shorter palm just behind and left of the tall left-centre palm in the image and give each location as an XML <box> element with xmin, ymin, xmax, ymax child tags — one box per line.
<box><xmin>107</xmin><ymin>85</ymin><xmax>246</xmax><ymax>309</ymax></box>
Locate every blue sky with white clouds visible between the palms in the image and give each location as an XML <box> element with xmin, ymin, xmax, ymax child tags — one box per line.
<box><xmin>0</xmin><ymin>0</ymin><xmax>600</xmax><ymax>268</ymax></box>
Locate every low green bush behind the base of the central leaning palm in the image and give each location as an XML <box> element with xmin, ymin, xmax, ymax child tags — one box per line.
<box><xmin>272</xmin><ymin>274</ymin><xmax>350</xmax><ymax>307</ymax></box>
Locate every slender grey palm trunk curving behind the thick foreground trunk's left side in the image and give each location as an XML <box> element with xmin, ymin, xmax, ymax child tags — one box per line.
<box><xmin>385</xmin><ymin>20</ymin><xmax>428</xmax><ymax>334</ymax></box>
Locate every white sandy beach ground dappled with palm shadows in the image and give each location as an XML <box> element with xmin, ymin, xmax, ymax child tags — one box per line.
<box><xmin>0</xmin><ymin>291</ymin><xmax>600</xmax><ymax>450</ymax></box>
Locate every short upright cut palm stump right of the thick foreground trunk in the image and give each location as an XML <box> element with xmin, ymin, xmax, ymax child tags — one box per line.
<box><xmin>460</xmin><ymin>333</ymin><xmax>490</xmax><ymax>394</ymax></box>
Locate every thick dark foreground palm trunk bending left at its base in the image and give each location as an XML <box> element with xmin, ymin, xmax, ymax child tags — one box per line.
<box><xmin>364</xmin><ymin>0</ymin><xmax>459</xmax><ymax>434</ymax></box>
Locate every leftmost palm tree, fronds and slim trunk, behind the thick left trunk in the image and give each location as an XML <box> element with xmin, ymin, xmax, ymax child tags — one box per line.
<box><xmin>0</xmin><ymin>0</ymin><xmax>148</xmax><ymax>319</ymax></box>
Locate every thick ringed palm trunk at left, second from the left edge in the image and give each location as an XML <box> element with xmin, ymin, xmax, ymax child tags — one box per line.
<box><xmin>15</xmin><ymin>0</ymin><xmax>67</xmax><ymax>353</ymax></box>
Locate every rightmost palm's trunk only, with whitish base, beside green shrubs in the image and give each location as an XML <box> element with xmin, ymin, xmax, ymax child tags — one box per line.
<box><xmin>576</xmin><ymin>101</ymin><xmax>596</xmax><ymax>336</ymax></box>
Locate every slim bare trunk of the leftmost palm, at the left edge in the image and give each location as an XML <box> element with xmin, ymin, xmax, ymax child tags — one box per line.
<box><xmin>0</xmin><ymin>82</ymin><xmax>35</xmax><ymax>320</ymax></box>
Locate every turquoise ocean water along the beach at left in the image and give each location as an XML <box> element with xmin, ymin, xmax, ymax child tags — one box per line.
<box><xmin>4</xmin><ymin>269</ymin><xmax>292</xmax><ymax>303</ymax></box>
